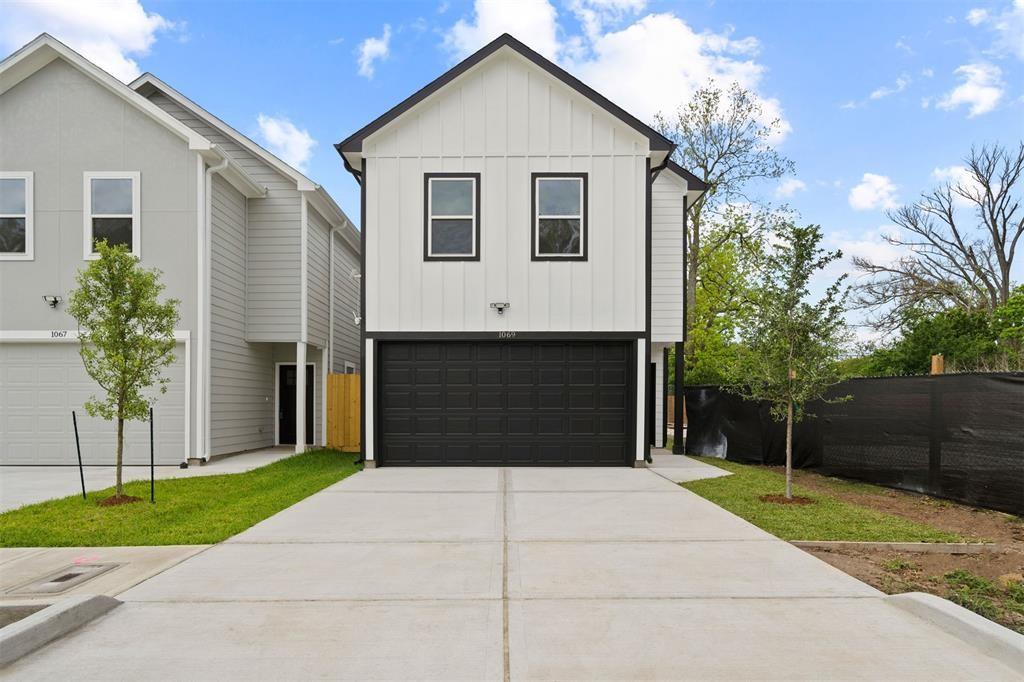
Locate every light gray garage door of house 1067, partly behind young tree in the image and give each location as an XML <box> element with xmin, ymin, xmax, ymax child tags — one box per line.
<box><xmin>0</xmin><ymin>343</ymin><xmax>187</xmax><ymax>466</ymax></box>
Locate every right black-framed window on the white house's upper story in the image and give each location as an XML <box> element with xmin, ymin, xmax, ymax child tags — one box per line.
<box><xmin>531</xmin><ymin>173</ymin><xmax>587</xmax><ymax>260</ymax></box>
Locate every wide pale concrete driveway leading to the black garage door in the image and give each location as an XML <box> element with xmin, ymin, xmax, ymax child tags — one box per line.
<box><xmin>4</xmin><ymin>469</ymin><xmax>1017</xmax><ymax>680</ymax></box>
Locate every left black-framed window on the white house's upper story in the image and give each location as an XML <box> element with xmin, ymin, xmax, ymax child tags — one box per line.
<box><xmin>423</xmin><ymin>173</ymin><xmax>480</xmax><ymax>260</ymax></box>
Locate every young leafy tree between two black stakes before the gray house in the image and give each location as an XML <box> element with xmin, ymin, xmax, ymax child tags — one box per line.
<box><xmin>68</xmin><ymin>241</ymin><xmax>179</xmax><ymax>500</ymax></box>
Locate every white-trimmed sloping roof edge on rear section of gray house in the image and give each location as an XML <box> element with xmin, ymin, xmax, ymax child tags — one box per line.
<box><xmin>130</xmin><ymin>73</ymin><xmax>359</xmax><ymax>249</ymax></box>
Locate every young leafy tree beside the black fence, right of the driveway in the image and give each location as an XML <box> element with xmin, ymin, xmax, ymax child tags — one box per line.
<box><xmin>730</xmin><ymin>222</ymin><xmax>849</xmax><ymax>499</ymax></box>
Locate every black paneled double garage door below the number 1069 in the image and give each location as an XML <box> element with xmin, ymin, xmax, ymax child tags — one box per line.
<box><xmin>377</xmin><ymin>340</ymin><xmax>634</xmax><ymax>466</ymax></box>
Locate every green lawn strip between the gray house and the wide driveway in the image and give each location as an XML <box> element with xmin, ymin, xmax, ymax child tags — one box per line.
<box><xmin>0</xmin><ymin>450</ymin><xmax>361</xmax><ymax>547</ymax></box>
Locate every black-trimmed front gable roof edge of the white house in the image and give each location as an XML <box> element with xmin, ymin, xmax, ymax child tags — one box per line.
<box><xmin>334</xmin><ymin>33</ymin><xmax>676</xmax><ymax>162</ymax></box>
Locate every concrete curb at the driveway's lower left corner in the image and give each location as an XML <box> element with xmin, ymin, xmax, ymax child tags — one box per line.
<box><xmin>0</xmin><ymin>594</ymin><xmax>121</xmax><ymax>668</ymax></box>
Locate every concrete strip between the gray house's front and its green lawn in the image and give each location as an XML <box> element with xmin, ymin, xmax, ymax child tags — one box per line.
<box><xmin>0</xmin><ymin>445</ymin><xmax>295</xmax><ymax>512</ymax></box>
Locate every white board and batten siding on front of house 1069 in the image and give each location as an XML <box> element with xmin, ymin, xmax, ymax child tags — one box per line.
<box><xmin>362</xmin><ymin>53</ymin><xmax>649</xmax><ymax>332</ymax></box>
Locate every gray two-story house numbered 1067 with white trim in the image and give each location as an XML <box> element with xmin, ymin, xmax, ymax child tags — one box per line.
<box><xmin>0</xmin><ymin>35</ymin><xmax>360</xmax><ymax>465</ymax></box>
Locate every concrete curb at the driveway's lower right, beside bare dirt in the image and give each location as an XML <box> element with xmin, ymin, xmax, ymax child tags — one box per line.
<box><xmin>885</xmin><ymin>592</ymin><xmax>1024</xmax><ymax>675</ymax></box>
